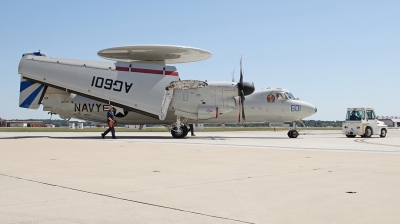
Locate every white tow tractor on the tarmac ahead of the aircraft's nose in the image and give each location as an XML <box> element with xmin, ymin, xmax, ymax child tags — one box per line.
<box><xmin>342</xmin><ymin>107</ymin><xmax>388</xmax><ymax>138</ymax></box>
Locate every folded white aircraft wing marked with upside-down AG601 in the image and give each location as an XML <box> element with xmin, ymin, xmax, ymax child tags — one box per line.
<box><xmin>18</xmin><ymin>55</ymin><xmax>179</xmax><ymax>118</ymax></box>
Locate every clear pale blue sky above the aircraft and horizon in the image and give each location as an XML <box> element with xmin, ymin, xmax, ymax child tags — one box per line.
<box><xmin>0</xmin><ymin>0</ymin><xmax>400</xmax><ymax>120</ymax></box>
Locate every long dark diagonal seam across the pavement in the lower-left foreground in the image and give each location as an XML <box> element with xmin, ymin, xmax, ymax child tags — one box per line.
<box><xmin>0</xmin><ymin>173</ymin><xmax>255</xmax><ymax>224</ymax></box>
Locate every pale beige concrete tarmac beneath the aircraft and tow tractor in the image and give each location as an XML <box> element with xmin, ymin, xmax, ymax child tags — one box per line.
<box><xmin>0</xmin><ymin>129</ymin><xmax>400</xmax><ymax>224</ymax></box>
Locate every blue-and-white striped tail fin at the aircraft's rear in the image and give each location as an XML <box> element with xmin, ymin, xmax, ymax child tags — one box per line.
<box><xmin>19</xmin><ymin>77</ymin><xmax>47</xmax><ymax>109</ymax></box>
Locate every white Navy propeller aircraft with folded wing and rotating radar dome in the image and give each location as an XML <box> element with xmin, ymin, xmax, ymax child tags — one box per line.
<box><xmin>18</xmin><ymin>45</ymin><xmax>317</xmax><ymax>138</ymax></box>
